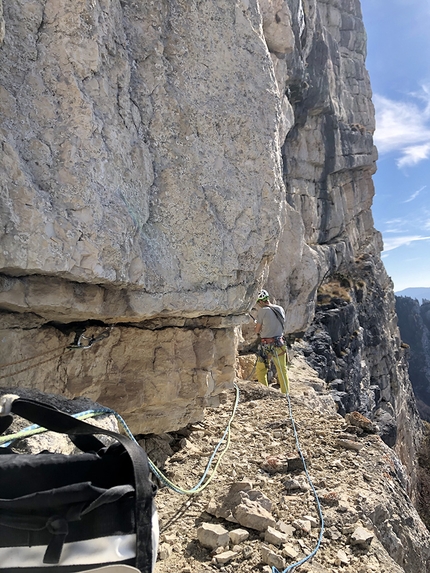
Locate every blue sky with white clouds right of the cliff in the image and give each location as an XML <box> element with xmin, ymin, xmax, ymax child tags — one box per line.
<box><xmin>361</xmin><ymin>0</ymin><xmax>430</xmax><ymax>291</ymax></box>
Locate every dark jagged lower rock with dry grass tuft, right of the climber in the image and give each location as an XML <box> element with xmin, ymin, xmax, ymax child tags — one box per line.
<box><xmin>293</xmin><ymin>255</ymin><xmax>423</xmax><ymax>502</ymax></box>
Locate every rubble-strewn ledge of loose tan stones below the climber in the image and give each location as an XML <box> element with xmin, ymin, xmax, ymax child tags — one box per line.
<box><xmin>155</xmin><ymin>360</ymin><xmax>429</xmax><ymax>573</ymax></box>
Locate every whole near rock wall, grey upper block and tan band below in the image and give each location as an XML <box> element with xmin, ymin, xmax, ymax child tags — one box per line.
<box><xmin>0</xmin><ymin>0</ymin><xmax>292</xmax><ymax>432</ymax></box>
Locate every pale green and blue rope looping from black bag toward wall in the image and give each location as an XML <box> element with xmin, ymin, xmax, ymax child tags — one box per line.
<box><xmin>0</xmin><ymin>384</ymin><xmax>240</xmax><ymax>495</ymax></box>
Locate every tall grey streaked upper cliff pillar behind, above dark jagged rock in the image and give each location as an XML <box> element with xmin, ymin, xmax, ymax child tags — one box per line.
<box><xmin>268</xmin><ymin>1</ymin><xmax>382</xmax><ymax>332</ymax></box>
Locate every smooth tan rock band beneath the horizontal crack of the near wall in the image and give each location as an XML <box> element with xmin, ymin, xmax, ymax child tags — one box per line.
<box><xmin>0</xmin><ymin>312</ymin><xmax>239</xmax><ymax>433</ymax></box>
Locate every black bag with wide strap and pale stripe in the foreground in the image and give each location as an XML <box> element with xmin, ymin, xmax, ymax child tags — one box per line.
<box><xmin>0</xmin><ymin>396</ymin><xmax>158</xmax><ymax>573</ymax></box>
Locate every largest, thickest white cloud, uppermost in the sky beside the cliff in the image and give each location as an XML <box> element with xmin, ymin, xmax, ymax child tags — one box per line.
<box><xmin>373</xmin><ymin>91</ymin><xmax>430</xmax><ymax>168</ymax></box>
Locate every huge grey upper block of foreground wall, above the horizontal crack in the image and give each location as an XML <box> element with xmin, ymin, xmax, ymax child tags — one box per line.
<box><xmin>0</xmin><ymin>0</ymin><xmax>283</xmax><ymax>308</ymax></box>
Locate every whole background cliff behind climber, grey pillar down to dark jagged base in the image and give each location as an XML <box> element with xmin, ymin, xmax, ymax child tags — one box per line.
<box><xmin>242</xmin><ymin>0</ymin><xmax>421</xmax><ymax>492</ymax></box>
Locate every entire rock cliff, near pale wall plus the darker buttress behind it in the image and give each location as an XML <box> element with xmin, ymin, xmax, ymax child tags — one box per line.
<box><xmin>0</xmin><ymin>0</ymin><xmax>421</xmax><ymax>500</ymax></box>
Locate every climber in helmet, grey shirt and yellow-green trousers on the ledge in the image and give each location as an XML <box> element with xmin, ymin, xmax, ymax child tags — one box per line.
<box><xmin>255</xmin><ymin>290</ymin><xmax>289</xmax><ymax>394</ymax></box>
